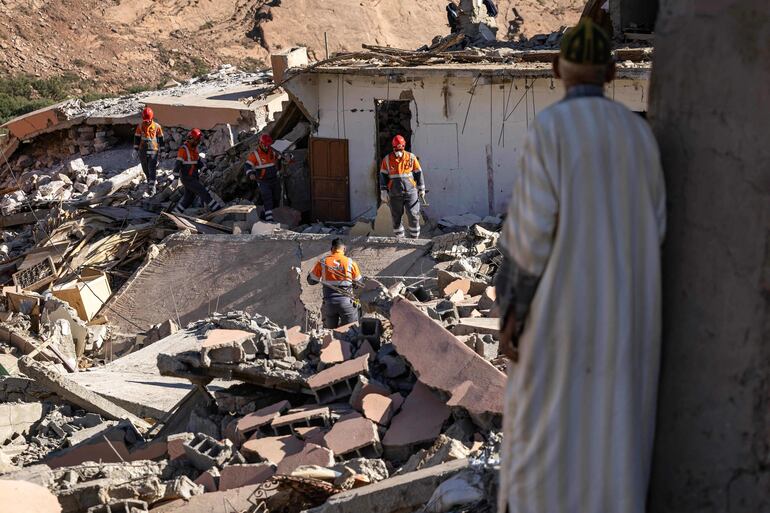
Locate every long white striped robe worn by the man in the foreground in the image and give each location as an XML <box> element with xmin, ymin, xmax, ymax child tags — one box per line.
<box><xmin>499</xmin><ymin>97</ymin><xmax>665</xmax><ymax>513</ymax></box>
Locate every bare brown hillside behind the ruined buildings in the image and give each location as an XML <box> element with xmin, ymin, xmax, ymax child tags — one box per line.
<box><xmin>0</xmin><ymin>0</ymin><xmax>583</xmax><ymax>91</ymax></box>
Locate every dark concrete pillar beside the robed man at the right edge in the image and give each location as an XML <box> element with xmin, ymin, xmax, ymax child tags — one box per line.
<box><xmin>649</xmin><ymin>0</ymin><xmax>770</xmax><ymax>513</ymax></box>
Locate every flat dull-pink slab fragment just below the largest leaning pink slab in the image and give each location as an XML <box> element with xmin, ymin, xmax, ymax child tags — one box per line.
<box><xmin>382</xmin><ymin>381</ymin><xmax>450</xmax><ymax>458</ymax></box>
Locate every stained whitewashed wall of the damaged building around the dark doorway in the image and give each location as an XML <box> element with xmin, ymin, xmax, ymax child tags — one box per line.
<box><xmin>289</xmin><ymin>74</ymin><xmax>647</xmax><ymax>218</ymax></box>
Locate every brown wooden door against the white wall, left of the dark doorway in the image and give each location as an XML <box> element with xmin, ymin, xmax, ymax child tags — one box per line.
<box><xmin>310</xmin><ymin>137</ymin><xmax>350</xmax><ymax>221</ymax></box>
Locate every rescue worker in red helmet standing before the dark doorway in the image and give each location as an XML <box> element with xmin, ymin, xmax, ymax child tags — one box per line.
<box><xmin>380</xmin><ymin>135</ymin><xmax>425</xmax><ymax>239</ymax></box>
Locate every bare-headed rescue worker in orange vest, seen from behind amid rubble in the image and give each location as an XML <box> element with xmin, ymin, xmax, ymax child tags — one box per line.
<box><xmin>307</xmin><ymin>239</ymin><xmax>363</xmax><ymax>329</ymax></box>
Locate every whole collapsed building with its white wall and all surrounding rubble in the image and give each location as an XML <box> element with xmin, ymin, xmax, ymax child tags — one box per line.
<box><xmin>0</xmin><ymin>2</ymin><xmax>650</xmax><ymax>513</ymax></box>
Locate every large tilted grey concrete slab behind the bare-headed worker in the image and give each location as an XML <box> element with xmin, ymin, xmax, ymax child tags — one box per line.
<box><xmin>102</xmin><ymin>234</ymin><xmax>432</xmax><ymax>333</ymax></box>
